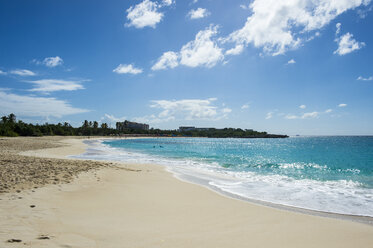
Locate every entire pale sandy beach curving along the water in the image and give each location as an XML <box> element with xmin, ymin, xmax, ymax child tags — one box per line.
<box><xmin>0</xmin><ymin>137</ymin><xmax>373</xmax><ymax>248</ymax></box>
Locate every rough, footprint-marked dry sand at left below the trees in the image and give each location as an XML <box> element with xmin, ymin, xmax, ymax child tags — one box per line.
<box><xmin>0</xmin><ymin>137</ymin><xmax>109</xmax><ymax>193</ymax></box>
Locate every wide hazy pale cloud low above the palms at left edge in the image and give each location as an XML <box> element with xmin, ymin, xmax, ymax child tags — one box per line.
<box><xmin>0</xmin><ymin>91</ymin><xmax>89</xmax><ymax>118</ymax></box>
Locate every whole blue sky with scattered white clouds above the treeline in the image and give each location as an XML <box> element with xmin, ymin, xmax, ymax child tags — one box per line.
<box><xmin>0</xmin><ymin>0</ymin><xmax>373</xmax><ymax>135</ymax></box>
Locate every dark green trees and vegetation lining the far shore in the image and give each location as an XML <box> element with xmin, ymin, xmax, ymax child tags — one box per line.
<box><xmin>0</xmin><ymin>114</ymin><xmax>288</xmax><ymax>138</ymax></box>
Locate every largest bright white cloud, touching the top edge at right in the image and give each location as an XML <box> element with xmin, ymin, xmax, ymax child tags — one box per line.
<box><xmin>226</xmin><ymin>0</ymin><xmax>370</xmax><ymax>55</ymax></box>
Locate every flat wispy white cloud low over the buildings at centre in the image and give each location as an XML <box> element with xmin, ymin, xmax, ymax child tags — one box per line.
<box><xmin>146</xmin><ymin>98</ymin><xmax>232</xmax><ymax>123</ymax></box>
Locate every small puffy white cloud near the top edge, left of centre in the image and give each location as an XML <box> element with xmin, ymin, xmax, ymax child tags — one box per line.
<box><xmin>126</xmin><ymin>0</ymin><xmax>163</xmax><ymax>28</ymax></box>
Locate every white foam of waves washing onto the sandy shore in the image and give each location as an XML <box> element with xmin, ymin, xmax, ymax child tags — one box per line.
<box><xmin>74</xmin><ymin>141</ymin><xmax>373</xmax><ymax>217</ymax></box>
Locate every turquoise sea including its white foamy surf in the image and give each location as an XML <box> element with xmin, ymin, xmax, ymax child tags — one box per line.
<box><xmin>73</xmin><ymin>136</ymin><xmax>373</xmax><ymax>217</ymax></box>
